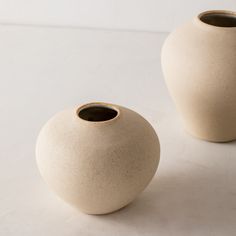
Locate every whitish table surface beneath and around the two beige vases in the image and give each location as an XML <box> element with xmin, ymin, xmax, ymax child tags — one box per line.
<box><xmin>0</xmin><ymin>25</ymin><xmax>236</xmax><ymax>236</ymax></box>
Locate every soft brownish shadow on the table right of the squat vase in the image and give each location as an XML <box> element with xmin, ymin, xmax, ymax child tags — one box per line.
<box><xmin>96</xmin><ymin>145</ymin><xmax>236</xmax><ymax>235</ymax></box>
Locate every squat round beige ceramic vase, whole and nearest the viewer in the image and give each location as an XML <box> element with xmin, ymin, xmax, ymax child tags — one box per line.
<box><xmin>36</xmin><ymin>103</ymin><xmax>160</xmax><ymax>214</ymax></box>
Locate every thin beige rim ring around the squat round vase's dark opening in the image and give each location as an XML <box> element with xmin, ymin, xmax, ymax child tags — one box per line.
<box><xmin>76</xmin><ymin>102</ymin><xmax>121</xmax><ymax>124</ymax></box>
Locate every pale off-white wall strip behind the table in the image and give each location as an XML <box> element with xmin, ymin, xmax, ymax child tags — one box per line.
<box><xmin>0</xmin><ymin>0</ymin><xmax>236</xmax><ymax>31</ymax></box>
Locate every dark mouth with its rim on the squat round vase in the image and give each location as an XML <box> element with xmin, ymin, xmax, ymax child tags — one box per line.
<box><xmin>77</xmin><ymin>103</ymin><xmax>120</xmax><ymax>122</ymax></box>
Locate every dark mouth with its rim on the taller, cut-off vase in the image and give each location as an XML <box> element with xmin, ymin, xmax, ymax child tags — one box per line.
<box><xmin>198</xmin><ymin>10</ymin><xmax>236</xmax><ymax>28</ymax></box>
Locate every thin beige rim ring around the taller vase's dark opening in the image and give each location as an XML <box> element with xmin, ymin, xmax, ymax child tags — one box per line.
<box><xmin>194</xmin><ymin>10</ymin><xmax>236</xmax><ymax>30</ymax></box>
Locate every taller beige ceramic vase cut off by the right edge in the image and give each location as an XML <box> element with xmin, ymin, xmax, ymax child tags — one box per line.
<box><xmin>162</xmin><ymin>11</ymin><xmax>236</xmax><ymax>142</ymax></box>
